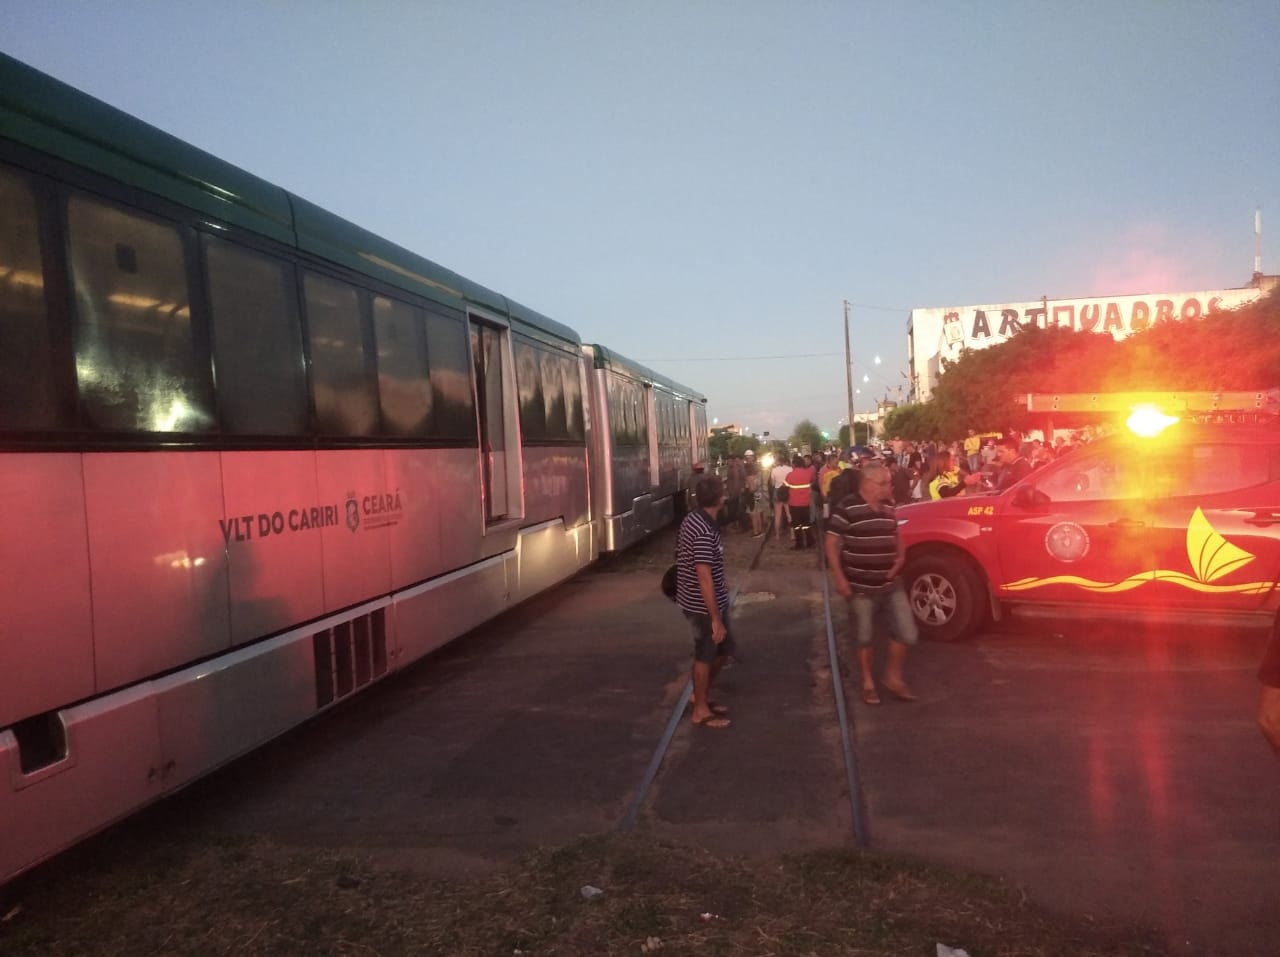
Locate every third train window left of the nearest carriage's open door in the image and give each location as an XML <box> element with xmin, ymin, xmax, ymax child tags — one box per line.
<box><xmin>303</xmin><ymin>273</ymin><xmax>378</xmax><ymax>435</ymax></box>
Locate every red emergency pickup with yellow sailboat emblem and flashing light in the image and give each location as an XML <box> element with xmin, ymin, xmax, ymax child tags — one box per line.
<box><xmin>897</xmin><ymin>389</ymin><xmax>1280</xmax><ymax>641</ymax></box>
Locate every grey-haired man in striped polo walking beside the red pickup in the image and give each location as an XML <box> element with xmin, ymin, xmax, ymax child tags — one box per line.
<box><xmin>824</xmin><ymin>462</ymin><xmax>919</xmax><ymax>705</ymax></box>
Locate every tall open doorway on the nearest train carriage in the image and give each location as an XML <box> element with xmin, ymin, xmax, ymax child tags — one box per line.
<box><xmin>470</xmin><ymin>315</ymin><xmax>522</xmax><ymax>526</ymax></box>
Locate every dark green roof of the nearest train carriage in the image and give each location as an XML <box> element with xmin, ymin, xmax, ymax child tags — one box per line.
<box><xmin>0</xmin><ymin>52</ymin><xmax>581</xmax><ymax>345</ymax></box>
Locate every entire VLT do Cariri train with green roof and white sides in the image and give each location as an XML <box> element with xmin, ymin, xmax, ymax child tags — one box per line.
<box><xmin>0</xmin><ymin>55</ymin><xmax>705</xmax><ymax>882</ymax></box>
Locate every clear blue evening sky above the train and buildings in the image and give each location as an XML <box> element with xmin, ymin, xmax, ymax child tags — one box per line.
<box><xmin>0</xmin><ymin>0</ymin><xmax>1280</xmax><ymax>435</ymax></box>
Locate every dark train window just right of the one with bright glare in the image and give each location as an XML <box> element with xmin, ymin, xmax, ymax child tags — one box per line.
<box><xmin>205</xmin><ymin>237</ymin><xmax>307</xmax><ymax>435</ymax></box>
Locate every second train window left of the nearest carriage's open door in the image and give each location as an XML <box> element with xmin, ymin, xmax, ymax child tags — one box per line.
<box><xmin>374</xmin><ymin>296</ymin><xmax>431</xmax><ymax>436</ymax></box>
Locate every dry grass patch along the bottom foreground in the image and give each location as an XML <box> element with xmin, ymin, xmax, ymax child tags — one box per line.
<box><xmin>0</xmin><ymin>835</ymin><xmax>1158</xmax><ymax>957</ymax></box>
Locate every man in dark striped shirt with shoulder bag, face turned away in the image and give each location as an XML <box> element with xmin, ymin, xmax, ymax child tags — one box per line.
<box><xmin>676</xmin><ymin>475</ymin><xmax>733</xmax><ymax>728</ymax></box>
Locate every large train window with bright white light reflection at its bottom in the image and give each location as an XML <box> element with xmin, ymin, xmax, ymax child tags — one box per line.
<box><xmin>67</xmin><ymin>194</ymin><xmax>214</xmax><ymax>432</ymax></box>
